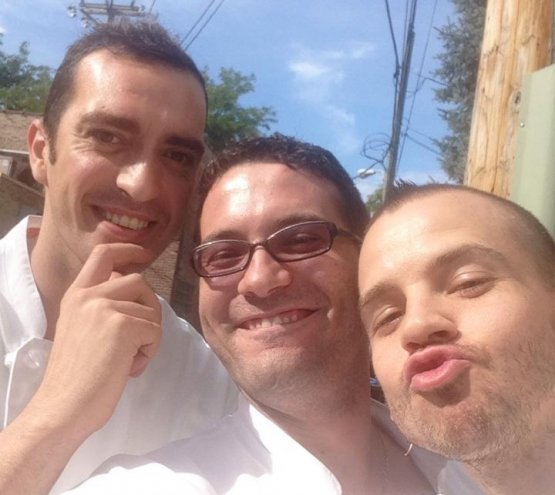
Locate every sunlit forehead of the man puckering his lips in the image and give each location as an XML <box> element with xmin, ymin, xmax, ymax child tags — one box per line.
<box><xmin>361</xmin><ymin>191</ymin><xmax>523</xmax><ymax>273</ymax></box>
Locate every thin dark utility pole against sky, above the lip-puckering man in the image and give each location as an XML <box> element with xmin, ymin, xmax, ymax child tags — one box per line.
<box><xmin>384</xmin><ymin>0</ymin><xmax>417</xmax><ymax>199</ymax></box>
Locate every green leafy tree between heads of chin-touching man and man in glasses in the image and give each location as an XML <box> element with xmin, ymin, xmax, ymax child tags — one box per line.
<box><xmin>204</xmin><ymin>68</ymin><xmax>276</xmax><ymax>152</ymax></box>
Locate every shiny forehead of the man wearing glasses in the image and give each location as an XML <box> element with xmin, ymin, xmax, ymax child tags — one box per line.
<box><xmin>200</xmin><ymin>162</ymin><xmax>341</xmax><ymax>236</ymax></box>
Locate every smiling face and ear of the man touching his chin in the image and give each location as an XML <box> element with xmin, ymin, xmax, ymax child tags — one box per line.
<box><xmin>30</xmin><ymin>50</ymin><xmax>205</xmax><ymax>272</ymax></box>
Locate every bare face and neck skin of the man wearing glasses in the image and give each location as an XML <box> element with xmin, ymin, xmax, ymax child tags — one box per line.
<box><xmin>200</xmin><ymin>162</ymin><xmax>440</xmax><ymax>495</ymax></box>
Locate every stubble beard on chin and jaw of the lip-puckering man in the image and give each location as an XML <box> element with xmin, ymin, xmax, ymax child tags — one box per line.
<box><xmin>390</xmin><ymin>336</ymin><xmax>555</xmax><ymax>467</ymax></box>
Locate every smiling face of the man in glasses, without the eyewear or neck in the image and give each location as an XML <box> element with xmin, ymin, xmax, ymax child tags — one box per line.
<box><xmin>200</xmin><ymin>163</ymin><xmax>368</xmax><ymax>401</ymax></box>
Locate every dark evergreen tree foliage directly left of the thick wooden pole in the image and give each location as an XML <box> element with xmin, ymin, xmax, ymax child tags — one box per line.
<box><xmin>434</xmin><ymin>0</ymin><xmax>487</xmax><ymax>183</ymax></box>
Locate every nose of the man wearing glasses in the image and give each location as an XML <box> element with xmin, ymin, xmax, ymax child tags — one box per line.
<box><xmin>237</xmin><ymin>246</ymin><xmax>292</xmax><ymax>297</ymax></box>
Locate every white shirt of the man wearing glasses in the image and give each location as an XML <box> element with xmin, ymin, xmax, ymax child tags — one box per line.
<box><xmin>64</xmin><ymin>397</ymin><xmax>480</xmax><ymax>495</ymax></box>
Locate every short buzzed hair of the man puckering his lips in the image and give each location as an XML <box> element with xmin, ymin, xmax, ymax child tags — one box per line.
<box><xmin>367</xmin><ymin>181</ymin><xmax>555</xmax><ymax>289</ymax></box>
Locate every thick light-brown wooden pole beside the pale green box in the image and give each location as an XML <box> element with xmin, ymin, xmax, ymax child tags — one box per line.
<box><xmin>465</xmin><ymin>0</ymin><xmax>554</xmax><ymax>198</ymax></box>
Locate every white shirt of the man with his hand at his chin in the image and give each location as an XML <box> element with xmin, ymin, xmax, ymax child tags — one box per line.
<box><xmin>0</xmin><ymin>217</ymin><xmax>237</xmax><ymax>494</ymax></box>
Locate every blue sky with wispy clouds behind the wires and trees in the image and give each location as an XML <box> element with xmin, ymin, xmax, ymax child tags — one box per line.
<box><xmin>0</xmin><ymin>0</ymin><xmax>453</xmax><ymax>202</ymax></box>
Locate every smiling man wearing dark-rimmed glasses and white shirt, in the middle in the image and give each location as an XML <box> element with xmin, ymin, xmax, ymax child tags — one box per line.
<box><xmin>63</xmin><ymin>135</ymin><xmax>476</xmax><ymax>495</ymax></box>
